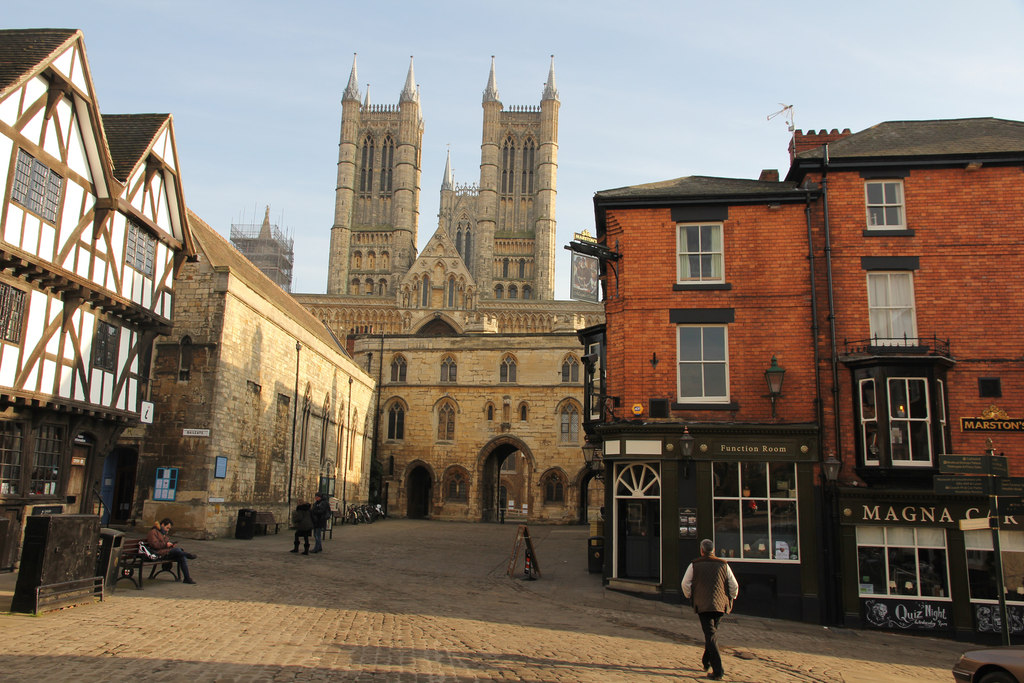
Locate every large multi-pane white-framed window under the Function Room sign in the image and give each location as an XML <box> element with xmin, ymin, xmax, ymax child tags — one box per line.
<box><xmin>712</xmin><ymin>462</ymin><xmax>800</xmax><ymax>561</ymax></box>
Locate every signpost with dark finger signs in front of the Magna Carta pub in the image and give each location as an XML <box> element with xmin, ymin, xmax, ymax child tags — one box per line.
<box><xmin>933</xmin><ymin>439</ymin><xmax>1024</xmax><ymax>645</ymax></box>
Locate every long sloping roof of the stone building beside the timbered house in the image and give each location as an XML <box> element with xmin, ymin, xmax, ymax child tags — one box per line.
<box><xmin>188</xmin><ymin>209</ymin><xmax>351</xmax><ymax>358</ymax></box>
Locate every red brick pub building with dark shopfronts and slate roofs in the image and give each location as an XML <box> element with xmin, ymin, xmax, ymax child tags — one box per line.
<box><xmin>589</xmin><ymin>119</ymin><xmax>1024</xmax><ymax>637</ymax></box>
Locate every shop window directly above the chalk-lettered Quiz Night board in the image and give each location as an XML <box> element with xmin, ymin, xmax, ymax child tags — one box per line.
<box><xmin>857</xmin><ymin>526</ymin><xmax>949</xmax><ymax>598</ymax></box>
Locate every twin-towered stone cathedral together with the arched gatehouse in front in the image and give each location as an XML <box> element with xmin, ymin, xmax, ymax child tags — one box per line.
<box><xmin>296</xmin><ymin>58</ymin><xmax>603</xmax><ymax>522</ymax></box>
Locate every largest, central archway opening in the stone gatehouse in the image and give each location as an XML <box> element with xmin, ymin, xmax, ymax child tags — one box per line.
<box><xmin>477</xmin><ymin>436</ymin><xmax>534</xmax><ymax>522</ymax></box>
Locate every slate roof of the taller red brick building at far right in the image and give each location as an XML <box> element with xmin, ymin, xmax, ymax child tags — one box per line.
<box><xmin>797</xmin><ymin>117</ymin><xmax>1024</xmax><ymax>163</ymax></box>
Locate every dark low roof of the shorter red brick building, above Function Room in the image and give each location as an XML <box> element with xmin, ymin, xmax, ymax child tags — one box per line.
<box><xmin>594</xmin><ymin>175</ymin><xmax>803</xmax><ymax>203</ymax></box>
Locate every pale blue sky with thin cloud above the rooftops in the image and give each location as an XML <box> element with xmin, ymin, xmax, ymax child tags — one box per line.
<box><xmin>0</xmin><ymin>0</ymin><xmax>1024</xmax><ymax>299</ymax></box>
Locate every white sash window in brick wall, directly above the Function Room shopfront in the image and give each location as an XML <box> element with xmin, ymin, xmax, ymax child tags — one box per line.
<box><xmin>678</xmin><ymin>325</ymin><xmax>729</xmax><ymax>403</ymax></box>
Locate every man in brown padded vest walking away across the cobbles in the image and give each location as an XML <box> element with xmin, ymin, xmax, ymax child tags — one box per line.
<box><xmin>682</xmin><ymin>539</ymin><xmax>739</xmax><ymax>681</ymax></box>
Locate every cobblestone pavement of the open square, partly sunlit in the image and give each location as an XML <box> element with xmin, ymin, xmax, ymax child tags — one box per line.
<box><xmin>0</xmin><ymin>519</ymin><xmax>969</xmax><ymax>683</ymax></box>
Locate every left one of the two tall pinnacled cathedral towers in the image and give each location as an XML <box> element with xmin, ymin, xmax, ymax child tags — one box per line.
<box><xmin>327</xmin><ymin>57</ymin><xmax>423</xmax><ymax>297</ymax></box>
